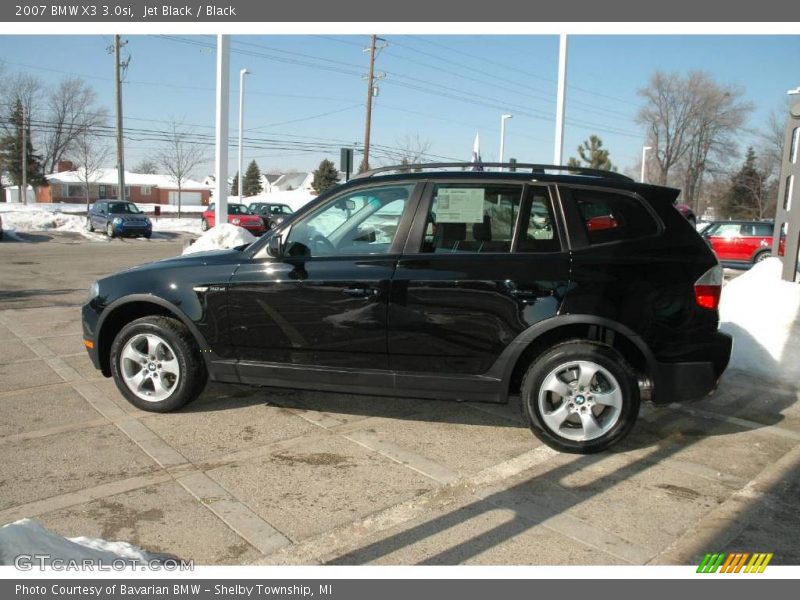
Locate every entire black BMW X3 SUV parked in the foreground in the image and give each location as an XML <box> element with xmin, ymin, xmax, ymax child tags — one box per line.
<box><xmin>83</xmin><ymin>163</ymin><xmax>732</xmax><ymax>453</ymax></box>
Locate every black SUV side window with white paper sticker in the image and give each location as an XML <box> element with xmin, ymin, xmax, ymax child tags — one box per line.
<box><xmin>421</xmin><ymin>183</ymin><xmax>522</xmax><ymax>252</ymax></box>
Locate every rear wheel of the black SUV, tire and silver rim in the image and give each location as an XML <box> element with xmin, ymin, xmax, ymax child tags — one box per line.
<box><xmin>520</xmin><ymin>340</ymin><xmax>640</xmax><ymax>454</ymax></box>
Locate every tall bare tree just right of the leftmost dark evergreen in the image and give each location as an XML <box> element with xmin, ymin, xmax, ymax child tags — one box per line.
<box><xmin>42</xmin><ymin>77</ymin><xmax>108</xmax><ymax>173</ymax></box>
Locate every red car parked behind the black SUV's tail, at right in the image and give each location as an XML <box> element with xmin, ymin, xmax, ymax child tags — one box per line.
<box><xmin>702</xmin><ymin>221</ymin><xmax>786</xmax><ymax>264</ymax></box>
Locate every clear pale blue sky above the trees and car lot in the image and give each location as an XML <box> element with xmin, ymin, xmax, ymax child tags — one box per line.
<box><xmin>0</xmin><ymin>35</ymin><xmax>800</xmax><ymax>176</ymax></box>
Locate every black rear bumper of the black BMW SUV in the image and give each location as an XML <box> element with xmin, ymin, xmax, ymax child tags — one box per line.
<box><xmin>653</xmin><ymin>331</ymin><xmax>733</xmax><ymax>404</ymax></box>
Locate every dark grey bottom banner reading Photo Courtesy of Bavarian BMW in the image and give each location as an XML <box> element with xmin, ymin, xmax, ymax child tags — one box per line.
<box><xmin>0</xmin><ymin>580</ymin><xmax>797</xmax><ymax>600</ymax></box>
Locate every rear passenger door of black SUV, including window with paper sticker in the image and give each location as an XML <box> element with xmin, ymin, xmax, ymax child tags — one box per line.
<box><xmin>388</xmin><ymin>180</ymin><xmax>569</xmax><ymax>375</ymax></box>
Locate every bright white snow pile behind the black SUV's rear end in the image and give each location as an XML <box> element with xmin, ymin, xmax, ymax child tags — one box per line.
<box><xmin>720</xmin><ymin>258</ymin><xmax>800</xmax><ymax>383</ymax></box>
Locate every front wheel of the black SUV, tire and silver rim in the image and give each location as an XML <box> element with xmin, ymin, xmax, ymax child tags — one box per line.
<box><xmin>109</xmin><ymin>316</ymin><xmax>208</xmax><ymax>412</ymax></box>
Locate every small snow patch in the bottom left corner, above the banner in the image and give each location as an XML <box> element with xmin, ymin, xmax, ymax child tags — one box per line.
<box><xmin>0</xmin><ymin>519</ymin><xmax>174</xmax><ymax>565</ymax></box>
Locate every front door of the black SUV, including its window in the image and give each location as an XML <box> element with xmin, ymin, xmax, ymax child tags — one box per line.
<box><xmin>228</xmin><ymin>184</ymin><xmax>416</xmax><ymax>372</ymax></box>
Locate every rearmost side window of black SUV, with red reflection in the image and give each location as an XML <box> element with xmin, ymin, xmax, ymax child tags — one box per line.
<box><xmin>572</xmin><ymin>189</ymin><xmax>658</xmax><ymax>244</ymax></box>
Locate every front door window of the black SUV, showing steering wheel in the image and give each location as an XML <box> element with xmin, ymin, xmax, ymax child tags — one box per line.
<box><xmin>285</xmin><ymin>184</ymin><xmax>414</xmax><ymax>256</ymax></box>
